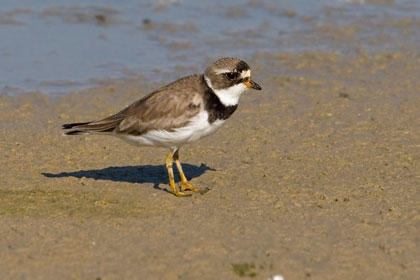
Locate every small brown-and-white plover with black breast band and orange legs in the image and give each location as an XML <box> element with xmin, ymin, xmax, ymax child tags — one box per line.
<box><xmin>63</xmin><ymin>57</ymin><xmax>261</xmax><ymax>196</ymax></box>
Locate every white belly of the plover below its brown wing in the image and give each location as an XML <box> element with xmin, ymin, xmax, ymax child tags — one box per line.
<box><xmin>118</xmin><ymin>110</ymin><xmax>225</xmax><ymax>148</ymax></box>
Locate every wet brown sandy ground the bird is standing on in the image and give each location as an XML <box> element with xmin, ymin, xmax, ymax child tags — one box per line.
<box><xmin>0</xmin><ymin>46</ymin><xmax>420</xmax><ymax>280</ymax></box>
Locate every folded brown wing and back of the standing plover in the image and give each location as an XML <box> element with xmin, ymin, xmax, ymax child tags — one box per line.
<box><xmin>63</xmin><ymin>75</ymin><xmax>203</xmax><ymax>135</ymax></box>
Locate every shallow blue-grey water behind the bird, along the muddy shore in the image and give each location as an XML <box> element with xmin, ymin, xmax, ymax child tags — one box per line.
<box><xmin>0</xmin><ymin>0</ymin><xmax>420</xmax><ymax>95</ymax></box>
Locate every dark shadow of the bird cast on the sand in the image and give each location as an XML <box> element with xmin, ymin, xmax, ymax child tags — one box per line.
<box><xmin>41</xmin><ymin>163</ymin><xmax>216</xmax><ymax>192</ymax></box>
